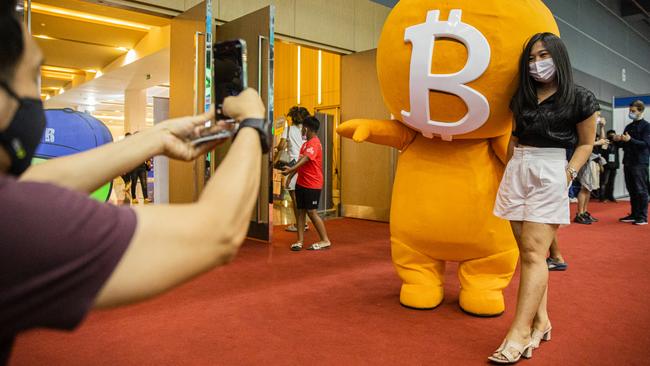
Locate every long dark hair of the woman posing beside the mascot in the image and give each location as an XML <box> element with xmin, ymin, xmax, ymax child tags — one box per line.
<box><xmin>510</xmin><ymin>33</ymin><xmax>575</xmax><ymax>117</ymax></box>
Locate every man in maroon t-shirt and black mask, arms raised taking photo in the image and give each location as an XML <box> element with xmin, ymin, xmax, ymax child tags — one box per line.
<box><xmin>0</xmin><ymin>0</ymin><xmax>269</xmax><ymax>365</ymax></box>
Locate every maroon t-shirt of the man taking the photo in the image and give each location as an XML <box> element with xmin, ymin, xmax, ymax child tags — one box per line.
<box><xmin>0</xmin><ymin>174</ymin><xmax>136</xmax><ymax>365</ymax></box>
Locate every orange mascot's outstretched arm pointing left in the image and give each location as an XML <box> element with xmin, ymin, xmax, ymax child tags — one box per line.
<box><xmin>336</xmin><ymin>119</ymin><xmax>417</xmax><ymax>150</ymax></box>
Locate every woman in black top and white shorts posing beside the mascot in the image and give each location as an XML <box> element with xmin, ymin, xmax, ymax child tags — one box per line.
<box><xmin>489</xmin><ymin>33</ymin><xmax>599</xmax><ymax>363</ymax></box>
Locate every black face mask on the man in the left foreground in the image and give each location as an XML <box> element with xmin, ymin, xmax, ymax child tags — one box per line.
<box><xmin>0</xmin><ymin>81</ymin><xmax>45</xmax><ymax>176</ymax></box>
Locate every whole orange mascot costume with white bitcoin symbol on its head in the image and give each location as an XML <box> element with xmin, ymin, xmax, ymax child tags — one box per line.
<box><xmin>337</xmin><ymin>0</ymin><xmax>559</xmax><ymax>316</ymax></box>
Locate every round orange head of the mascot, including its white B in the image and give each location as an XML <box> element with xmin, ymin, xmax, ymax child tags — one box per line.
<box><xmin>377</xmin><ymin>0</ymin><xmax>559</xmax><ymax>141</ymax></box>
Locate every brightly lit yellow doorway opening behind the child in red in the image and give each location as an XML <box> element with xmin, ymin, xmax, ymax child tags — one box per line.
<box><xmin>272</xmin><ymin>39</ymin><xmax>341</xmax><ymax>229</ymax></box>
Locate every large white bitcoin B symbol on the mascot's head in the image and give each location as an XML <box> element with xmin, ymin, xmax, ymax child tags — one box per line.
<box><xmin>402</xmin><ymin>9</ymin><xmax>490</xmax><ymax>141</ymax></box>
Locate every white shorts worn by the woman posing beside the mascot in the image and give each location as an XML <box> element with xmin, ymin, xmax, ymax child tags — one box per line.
<box><xmin>494</xmin><ymin>147</ymin><xmax>570</xmax><ymax>225</ymax></box>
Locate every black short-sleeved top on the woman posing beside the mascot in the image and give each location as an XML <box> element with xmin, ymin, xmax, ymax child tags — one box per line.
<box><xmin>512</xmin><ymin>85</ymin><xmax>600</xmax><ymax>149</ymax></box>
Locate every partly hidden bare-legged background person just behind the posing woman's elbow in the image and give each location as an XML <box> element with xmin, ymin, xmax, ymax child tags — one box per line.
<box><xmin>573</xmin><ymin>112</ymin><xmax>609</xmax><ymax>225</ymax></box>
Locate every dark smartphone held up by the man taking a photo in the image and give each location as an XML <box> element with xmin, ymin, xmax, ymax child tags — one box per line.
<box><xmin>213</xmin><ymin>39</ymin><xmax>248</xmax><ymax>120</ymax></box>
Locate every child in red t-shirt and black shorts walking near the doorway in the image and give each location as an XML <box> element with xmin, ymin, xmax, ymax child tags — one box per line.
<box><xmin>282</xmin><ymin>117</ymin><xmax>331</xmax><ymax>251</ymax></box>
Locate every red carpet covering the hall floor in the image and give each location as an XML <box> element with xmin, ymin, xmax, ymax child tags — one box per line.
<box><xmin>10</xmin><ymin>202</ymin><xmax>650</xmax><ymax>366</ymax></box>
